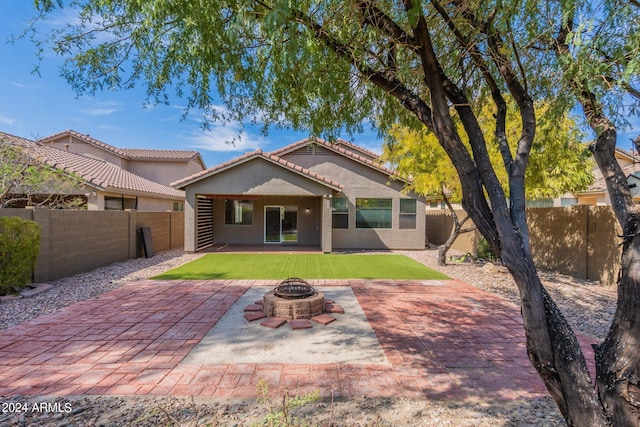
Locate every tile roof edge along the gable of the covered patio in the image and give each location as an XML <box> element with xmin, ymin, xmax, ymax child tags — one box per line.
<box><xmin>171</xmin><ymin>149</ymin><xmax>344</xmax><ymax>191</ymax></box>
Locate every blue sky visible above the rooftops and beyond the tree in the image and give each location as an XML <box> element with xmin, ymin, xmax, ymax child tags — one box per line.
<box><xmin>0</xmin><ymin>0</ymin><xmax>640</xmax><ymax>167</ymax></box>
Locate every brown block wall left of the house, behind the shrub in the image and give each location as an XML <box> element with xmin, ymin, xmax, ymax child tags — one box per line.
<box><xmin>0</xmin><ymin>208</ymin><xmax>184</xmax><ymax>282</ymax></box>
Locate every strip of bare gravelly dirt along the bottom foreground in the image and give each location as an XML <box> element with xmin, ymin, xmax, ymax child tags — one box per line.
<box><xmin>0</xmin><ymin>396</ymin><xmax>564</xmax><ymax>427</ymax></box>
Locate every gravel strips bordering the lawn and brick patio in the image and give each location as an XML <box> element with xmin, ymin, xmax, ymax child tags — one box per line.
<box><xmin>0</xmin><ymin>250</ymin><xmax>616</xmax><ymax>426</ymax></box>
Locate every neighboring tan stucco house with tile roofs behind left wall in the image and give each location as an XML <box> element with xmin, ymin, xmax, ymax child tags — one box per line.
<box><xmin>0</xmin><ymin>130</ymin><xmax>205</xmax><ymax>211</ymax></box>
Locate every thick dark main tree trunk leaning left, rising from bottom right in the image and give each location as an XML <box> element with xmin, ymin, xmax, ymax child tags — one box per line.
<box><xmin>406</xmin><ymin>9</ymin><xmax>607</xmax><ymax>427</ymax></box>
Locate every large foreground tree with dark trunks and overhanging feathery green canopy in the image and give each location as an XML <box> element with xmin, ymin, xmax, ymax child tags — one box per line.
<box><xmin>31</xmin><ymin>0</ymin><xmax>640</xmax><ymax>426</ymax></box>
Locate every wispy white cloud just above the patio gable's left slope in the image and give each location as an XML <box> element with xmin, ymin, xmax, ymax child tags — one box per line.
<box><xmin>185</xmin><ymin>125</ymin><xmax>267</xmax><ymax>152</ymax></box>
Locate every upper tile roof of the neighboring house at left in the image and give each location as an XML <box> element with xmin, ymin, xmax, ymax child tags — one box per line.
<box><xmin>38</xmin><ymin>129</ymin><xmax>205</xmax><ymax>169</ymax></box>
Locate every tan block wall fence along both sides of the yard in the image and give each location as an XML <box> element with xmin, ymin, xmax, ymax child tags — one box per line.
<box><xmin>0</xmin><ymin>205</ymin><xmax>621</xmax><ymax>285</ymax></box>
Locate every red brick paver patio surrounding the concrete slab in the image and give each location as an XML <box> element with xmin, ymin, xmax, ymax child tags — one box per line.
<box><xmin>0</xmin><ymin>280</ymin><xmax>592</xmax><ymax>400</ymax></box>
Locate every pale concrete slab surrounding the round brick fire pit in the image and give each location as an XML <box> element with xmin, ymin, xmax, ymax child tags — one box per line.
<box><xmin>182</xmin><ymin>286</ymin><xmax>388</xmax><ymax>365</ymax></box>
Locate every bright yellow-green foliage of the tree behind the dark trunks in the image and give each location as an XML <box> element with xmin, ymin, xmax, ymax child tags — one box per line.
<box><xmin>383</xmin><ymin>103</ymin><xmax>594</xmax><ymax>203</ymax></box>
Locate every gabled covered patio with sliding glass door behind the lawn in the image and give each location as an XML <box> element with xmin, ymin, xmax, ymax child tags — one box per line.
<box><xmin>176</xmin><ymin>150</ymin><xmax>343</xmax><ymax>252</ymax></box>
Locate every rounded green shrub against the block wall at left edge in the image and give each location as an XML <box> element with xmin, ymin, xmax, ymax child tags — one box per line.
<box><xmin>0</xmin><ymin>216</ymin><xmax>40</xmax><ymax>295</ymax></box>
